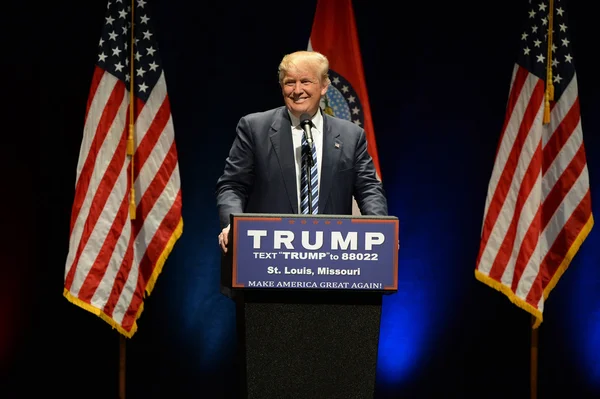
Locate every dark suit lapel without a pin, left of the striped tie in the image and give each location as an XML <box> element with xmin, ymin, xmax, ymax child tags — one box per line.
<box><xmin>267</xmin><ymin>107</ymin><xmax>298</xmax><ymax>213</ymax></box>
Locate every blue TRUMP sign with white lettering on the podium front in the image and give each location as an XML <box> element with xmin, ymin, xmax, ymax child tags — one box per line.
<box><xmin>230</xmin><ymin>214</ymin><xmax>399</xmax><ymax>292</ymax></box>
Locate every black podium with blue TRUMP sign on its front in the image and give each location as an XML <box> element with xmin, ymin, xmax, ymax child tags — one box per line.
<box><xmin>221</xmin><ymin>213</ymin><xmax>399</xmax><ymax>399</ymax></box>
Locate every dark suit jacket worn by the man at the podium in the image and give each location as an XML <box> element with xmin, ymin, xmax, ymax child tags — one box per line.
<box><xmin>217</xmin><ymin>106</ymin><xmax>387</xmax><ymax>227</ymax></box>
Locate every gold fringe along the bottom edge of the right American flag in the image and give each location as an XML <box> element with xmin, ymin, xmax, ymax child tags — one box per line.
<box><xmin>475</xmin><ymin>214</ymin><xmax>594</xmax><ymax>328</ymax></box>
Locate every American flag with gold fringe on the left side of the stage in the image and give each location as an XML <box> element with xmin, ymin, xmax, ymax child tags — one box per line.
<box><xmin>64</xmin><ymin>0</ymin><xmax>183</xmax><ymax>337</ymax></box>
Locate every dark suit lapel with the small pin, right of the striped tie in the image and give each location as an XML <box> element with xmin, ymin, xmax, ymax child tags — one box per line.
<box><xmin>319</xmin><ymin>112</ymin><xmax>342</xmax><ymax>213</ymax></box>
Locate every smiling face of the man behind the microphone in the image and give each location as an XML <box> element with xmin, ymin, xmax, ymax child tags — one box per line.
<box><xmin>281</xmin><ymin>64</ymin><xmax>327</xmax><ymax>118</ymax></box>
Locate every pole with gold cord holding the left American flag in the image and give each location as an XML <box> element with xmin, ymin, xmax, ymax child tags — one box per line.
<box><xmin>119</xmin><ymin>0</ymin><xmax>135</xmax><ymax>399</ymax></box>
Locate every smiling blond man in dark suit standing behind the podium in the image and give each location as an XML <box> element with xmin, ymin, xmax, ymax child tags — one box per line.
<box><xmin>216</xmin><ymin>51</ymin><xmax>387</xmax><ymax>251</ymax></box>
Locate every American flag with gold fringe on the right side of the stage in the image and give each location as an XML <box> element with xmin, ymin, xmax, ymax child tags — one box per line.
<box><xmin>475</xmin><ymin>0</ymin><xmax>594</xmax><ymax>328</ymax></box>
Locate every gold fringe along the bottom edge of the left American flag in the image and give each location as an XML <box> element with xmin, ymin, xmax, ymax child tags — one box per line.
<box><xmin>63</xmin><ymin>218</ymin><xmax>183</xmax><ymax>338</ymax></box>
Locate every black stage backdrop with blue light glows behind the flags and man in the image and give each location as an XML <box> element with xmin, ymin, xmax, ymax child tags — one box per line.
<box><xmin>0</xmin><ymin>0</ymin><xmax>600</xmax><ymax>399</ymax></box>
